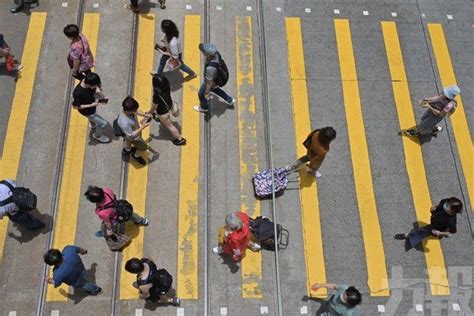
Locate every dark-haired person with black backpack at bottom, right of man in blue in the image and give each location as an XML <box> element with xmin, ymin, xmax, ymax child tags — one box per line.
<box><xmin>125</xmin><ymin>258</ymin><xmax>180</xmax><ymax>306</ymax></box>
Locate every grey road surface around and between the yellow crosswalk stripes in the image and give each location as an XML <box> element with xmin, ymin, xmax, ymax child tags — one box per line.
<box><xmin>0</xmin><ymin>0</ymin><xmax>474</xmax><ymax>316</ymax></box>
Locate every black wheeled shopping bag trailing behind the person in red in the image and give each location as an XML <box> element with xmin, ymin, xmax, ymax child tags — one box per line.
<box><xmin>250</xmin><ymin>216</ymin><xmax>289</xmax><ymax>251</ymax></box>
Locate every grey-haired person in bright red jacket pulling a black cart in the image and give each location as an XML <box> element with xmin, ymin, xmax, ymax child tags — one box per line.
<box><xmin>212</xmin><ymin>211</ymin><xmax>260</xmax><ymax>262</ymax></box>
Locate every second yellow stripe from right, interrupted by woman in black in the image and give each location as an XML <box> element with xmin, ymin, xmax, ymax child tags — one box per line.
<box><xmin>381</xmin><ymin>21</ymin><xmax>449</xmax><ymax>295</ymax></box>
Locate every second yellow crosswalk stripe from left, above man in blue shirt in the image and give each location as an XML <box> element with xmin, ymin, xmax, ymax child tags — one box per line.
<box><xmin>46</xmin><ymin>13</ymin><xmax>100</xmax><ymax>302</ymax></box>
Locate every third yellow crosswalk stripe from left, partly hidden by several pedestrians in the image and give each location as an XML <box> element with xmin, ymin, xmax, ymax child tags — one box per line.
<box><xmin>120</xmin><ymin>14</ymin><xmax>155</xmax><ymax>300</ymax></box>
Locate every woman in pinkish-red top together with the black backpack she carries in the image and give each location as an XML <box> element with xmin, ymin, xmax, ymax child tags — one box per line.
<box><xmin>84</xmin><ymin>186</ymin><xmax>149</xmax><ymax>237</ymax></box>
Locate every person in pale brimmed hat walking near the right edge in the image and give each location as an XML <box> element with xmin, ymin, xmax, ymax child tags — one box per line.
<box><xmin>405</xmin><ymin>85</ymin><xmax>461</xmax><ymax>137</ymax></box>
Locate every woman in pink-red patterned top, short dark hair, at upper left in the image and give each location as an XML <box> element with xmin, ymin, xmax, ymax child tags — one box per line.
<box><xmin>63</xmin><ymin>24</ymin><xmax>94</xmax><ymax>80</ymax></box>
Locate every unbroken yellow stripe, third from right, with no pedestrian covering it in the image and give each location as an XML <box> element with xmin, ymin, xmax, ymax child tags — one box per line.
<box><xmin>334</xmin><ymin>19</ymin><xmax>390</xmax><ymax>296</ymax></box>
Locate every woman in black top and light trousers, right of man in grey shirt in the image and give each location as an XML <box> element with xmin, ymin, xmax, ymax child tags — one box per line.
<box><xmin>148</xmin><ymin>75</ymin><xmax>186</xmax><ymax>146</ymax></box>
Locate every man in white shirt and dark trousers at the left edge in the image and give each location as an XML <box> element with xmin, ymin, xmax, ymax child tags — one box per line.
<box><xmin>0</xmin><ymin>179</ymin><xmax>45</xmax><ymax>230</ymax></box>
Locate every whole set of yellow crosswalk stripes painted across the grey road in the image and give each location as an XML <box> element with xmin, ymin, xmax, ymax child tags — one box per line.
<box><xmin>0</xmin><ymin>13</ymin><xmax>474</xmax><ymax>308</ymax></box>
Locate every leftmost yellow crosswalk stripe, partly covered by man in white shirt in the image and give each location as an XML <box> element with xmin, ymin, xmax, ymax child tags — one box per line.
<box><xmin>0</xmin><ymin>12</ymin><xmax>47</xmax><ymax>262</ymax></box>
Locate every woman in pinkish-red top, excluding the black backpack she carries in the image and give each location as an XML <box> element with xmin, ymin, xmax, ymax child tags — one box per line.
<box><xmin>84</xmin><ymin>186</ymin><xmax>149</xmax><ymax>237</ymax></box>
